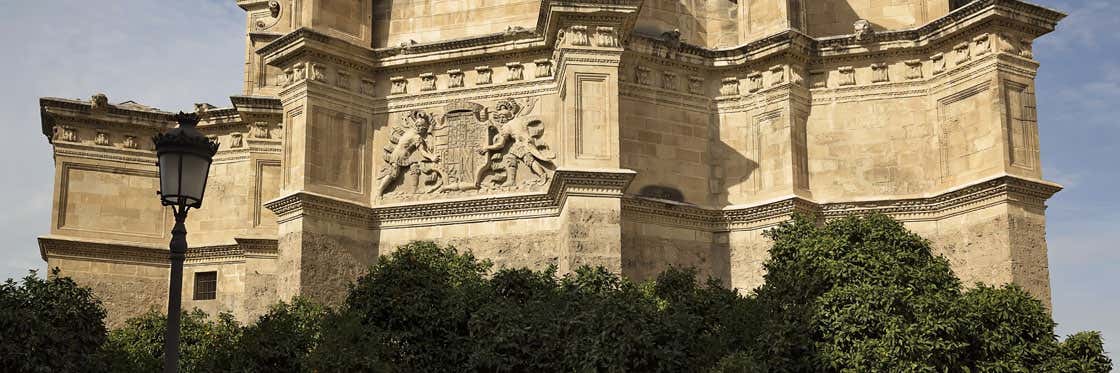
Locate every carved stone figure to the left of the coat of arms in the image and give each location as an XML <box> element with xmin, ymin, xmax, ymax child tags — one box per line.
<box><xmin>377</xmin><ymin>111</ymin><xmax>442</xmax><ymax>195</ymax></box>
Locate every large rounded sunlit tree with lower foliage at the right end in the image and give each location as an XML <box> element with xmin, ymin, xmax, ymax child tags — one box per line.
<box><xmin>721</xmin><ymin>215</ymin><xmax>1111</xmax><ymax>372</ymax></box>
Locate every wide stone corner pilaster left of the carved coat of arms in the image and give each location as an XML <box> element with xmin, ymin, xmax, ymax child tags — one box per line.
<box><xmin>262</xmin><ymin>28</ymin><xmax>377</xmax><ymax>301</ymax></box>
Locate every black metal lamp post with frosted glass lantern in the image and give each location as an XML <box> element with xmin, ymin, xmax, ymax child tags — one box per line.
<box><xmin>152</xmin><ymin>112</ymin><xmax>217</xmax><ymax>372</ymax></box>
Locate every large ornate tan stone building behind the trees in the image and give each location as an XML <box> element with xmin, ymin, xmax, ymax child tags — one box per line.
<box><xmin>39</xmin><ymin>0</ymin><xmax>1064</xmax><ymax>325</ymax></box>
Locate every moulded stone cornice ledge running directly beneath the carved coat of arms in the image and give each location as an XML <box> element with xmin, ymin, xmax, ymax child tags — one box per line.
<box><xmin>264</xmin><ymin>168</ymin><xmax>637</xmax><ymax>226</ymax></box>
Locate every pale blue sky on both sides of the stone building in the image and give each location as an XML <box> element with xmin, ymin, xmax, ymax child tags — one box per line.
<box><xmin>0</xmin><ymin>0</ymin><xmax>1120</xmax><ymax>357</ymax></box>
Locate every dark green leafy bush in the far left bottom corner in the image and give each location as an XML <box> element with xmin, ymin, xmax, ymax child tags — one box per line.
<box><xmin>0</xmin><ymin>269</ymin><xmax>105</xmax><ymax>372</ymax></box>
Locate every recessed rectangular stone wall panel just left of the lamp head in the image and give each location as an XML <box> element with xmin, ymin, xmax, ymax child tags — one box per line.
<box><xmin>57</xmin><ymin>164</ymin><xmax>168</xmax><ymax>239</ymax></box>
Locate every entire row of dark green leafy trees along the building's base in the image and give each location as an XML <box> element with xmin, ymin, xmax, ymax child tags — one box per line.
<box><xmin>0</xmin><ymin>215</ymin><xmax>1112</xmax><ymax>372</ymax></box>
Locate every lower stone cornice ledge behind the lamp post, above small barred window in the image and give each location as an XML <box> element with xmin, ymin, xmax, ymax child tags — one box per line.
<box><xmin>39</xmin><ymin>236</ymin><xmax>278</xmax><ymax>265</ymax></box>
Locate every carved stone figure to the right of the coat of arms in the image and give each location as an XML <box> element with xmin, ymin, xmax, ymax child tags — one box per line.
<box><xmin>478</xmin><ymin>99</ymin><xmax>556</xmax><ymax>187</ymax></box>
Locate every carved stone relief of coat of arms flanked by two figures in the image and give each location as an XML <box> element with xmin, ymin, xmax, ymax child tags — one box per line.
<box><xmin>377</xmin><ymin>99</ymin><xmax>556</xmax><ymax>201</ymax></box>
